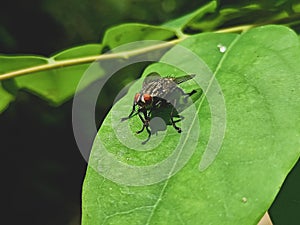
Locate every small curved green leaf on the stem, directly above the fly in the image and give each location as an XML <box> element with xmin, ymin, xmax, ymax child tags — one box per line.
<box><xmin>103</xmin><ymin>23</ymin><xmax>176</xmax><ymax>49</ymax></box>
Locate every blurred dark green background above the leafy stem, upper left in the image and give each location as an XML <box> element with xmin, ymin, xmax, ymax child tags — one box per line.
<box><xmin>0</xmin><ymin>0</ymin><xmax>205</xmax><ymax>56</ymax></box>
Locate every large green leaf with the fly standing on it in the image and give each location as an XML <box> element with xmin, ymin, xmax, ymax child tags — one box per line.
<box><xmin>82</xmin><ymin>26</ymin><xmax>300</xmax><ymax>225</ymax></box>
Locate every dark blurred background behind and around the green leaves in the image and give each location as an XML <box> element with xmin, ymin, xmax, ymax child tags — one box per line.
<box><xmin>0</xmin><ymin>0</ymin><xmax>300</xmax><ymax>225</ymax></box>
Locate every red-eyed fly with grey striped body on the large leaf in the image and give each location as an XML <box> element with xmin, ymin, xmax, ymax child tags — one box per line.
<box><xmin>121</xmin><ymin>73</ymin><xmax>196</xmax><ymax>144</ymax></box>
